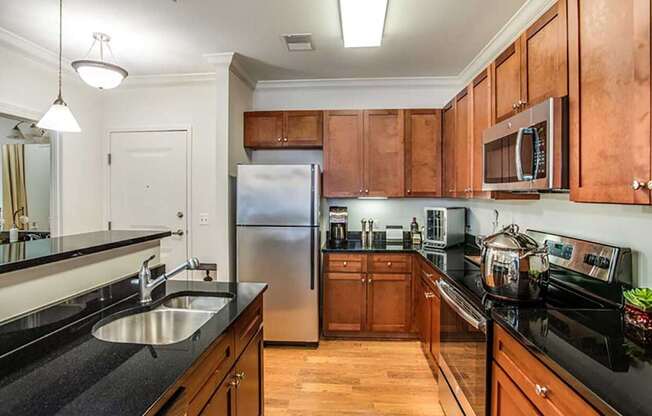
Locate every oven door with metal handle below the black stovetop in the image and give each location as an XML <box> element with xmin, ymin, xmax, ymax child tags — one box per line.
<box><xmin>437</xmin><ymin>280</ymin><xmax>489</xmax><ymax>416</ymax></box>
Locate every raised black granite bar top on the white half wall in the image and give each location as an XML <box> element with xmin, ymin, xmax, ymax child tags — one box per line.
<box><xmin>0</xmin><ymin>230</ymin><xmax>170</xmax><ymax>273</ymax></box>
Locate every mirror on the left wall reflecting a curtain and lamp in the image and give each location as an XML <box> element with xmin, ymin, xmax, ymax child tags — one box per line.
<box><xmin>0</xmin><ymin>114</ymin><xmax>52</xmax><ymax>243</ymax></box>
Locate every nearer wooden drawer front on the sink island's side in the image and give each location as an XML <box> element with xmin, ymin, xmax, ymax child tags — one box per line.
<box><xmin>183</xmin><ymin>330</ymin><xmax>235</xmax><ymax>416</ymax></box>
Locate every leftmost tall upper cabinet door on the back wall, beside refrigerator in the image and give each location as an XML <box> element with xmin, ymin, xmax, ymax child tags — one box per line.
<box><xmin>323</xmin><ymin>111</ymin><xmax>364</xmax><ymax>197</ymax></box>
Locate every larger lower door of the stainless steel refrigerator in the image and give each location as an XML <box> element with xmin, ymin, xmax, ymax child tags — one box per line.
<box><xmin>237</xmin><ymin>226</ymin><xmax>319</xmax><ymax>342</ymax></box>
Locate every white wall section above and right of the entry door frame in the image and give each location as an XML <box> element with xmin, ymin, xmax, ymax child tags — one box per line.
<box><xmin>102</xmin><ymin>81</ymin><xmax>225</xmax><ymax>274</ymax></box>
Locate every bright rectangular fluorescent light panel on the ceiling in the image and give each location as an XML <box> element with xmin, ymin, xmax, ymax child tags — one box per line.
<box><xmin>340</xmin><ymin>0</ymin><xmax>388</xmax><ymax>48</ymax></box>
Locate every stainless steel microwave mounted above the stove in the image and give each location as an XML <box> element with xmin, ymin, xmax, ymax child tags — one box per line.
<box><xmin>482</xmin><ymin>98</ymin><xmax>568</xmax><ymax>191</ymax></box>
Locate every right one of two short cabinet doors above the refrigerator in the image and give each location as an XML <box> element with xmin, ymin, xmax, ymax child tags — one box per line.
<box><xmin>283</xmin><ymin>111</ymin><xmax>324</xmax><ymax>148</ymax></box>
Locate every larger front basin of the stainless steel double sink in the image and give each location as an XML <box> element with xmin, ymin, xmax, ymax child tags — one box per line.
<box><xmin>93</xmin><ymin>307</ymin><xmax>215</xmax><ymax>345</ymax></box>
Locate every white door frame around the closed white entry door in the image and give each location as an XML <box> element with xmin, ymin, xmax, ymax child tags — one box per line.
<box><xmin>102</xmin><ymin>124</ymin><xmax>193</xmax><ymax>258</ymax></box>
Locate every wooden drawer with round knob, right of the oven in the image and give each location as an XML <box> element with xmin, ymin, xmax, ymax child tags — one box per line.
<box><xmin>493</xmin><ymin>325</ymin><xmax>599</xmax><ymax>416</ymax></box>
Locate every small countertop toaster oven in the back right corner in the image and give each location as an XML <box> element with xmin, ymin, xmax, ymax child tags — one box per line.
<box><xmin>423</xmin><ymin>208</ymin><xmax>466</xmax><ymax>249</ymax></box>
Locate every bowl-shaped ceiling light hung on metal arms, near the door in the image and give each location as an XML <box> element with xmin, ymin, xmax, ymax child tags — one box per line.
<box><xmin>72</xmin><ymin>32</ymin><xmax>128</xmax><ymax>90</ymax></box>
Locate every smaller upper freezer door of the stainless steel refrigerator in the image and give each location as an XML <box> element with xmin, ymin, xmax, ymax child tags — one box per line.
<box><xmin>236</xmin><ymin>165</ymin><xmax>320</xmax><ymax>226</ymax></box>
